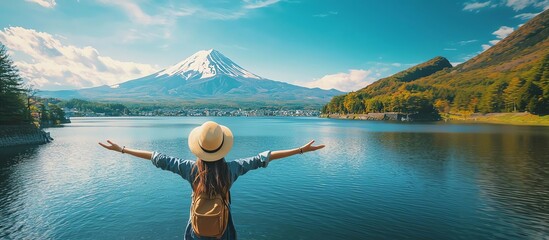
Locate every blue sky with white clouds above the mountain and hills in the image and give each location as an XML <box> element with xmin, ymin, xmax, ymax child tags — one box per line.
<box><xmin>0</xmin><ymin>0</ymin><xmax>549</xmax><ymax>91</ymax></box>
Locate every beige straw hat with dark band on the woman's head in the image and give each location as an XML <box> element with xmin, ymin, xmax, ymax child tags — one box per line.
<box><xmin>189</xmin><ymin>121</ymin><xmax>233</xmax><ymax>162</ymax></box>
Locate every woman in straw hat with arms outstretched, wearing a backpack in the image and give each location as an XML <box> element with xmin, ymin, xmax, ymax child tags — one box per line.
<box><xmin>99</xmin><ymin>121</ymin><xmax>324</xmax><ymax>239</ymax></box>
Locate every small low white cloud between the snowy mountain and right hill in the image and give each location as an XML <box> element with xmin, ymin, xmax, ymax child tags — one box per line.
<box><xmin>300</xmin><ymin>69</ymin><xmax>377</xmax><ymax>92</ymax></box>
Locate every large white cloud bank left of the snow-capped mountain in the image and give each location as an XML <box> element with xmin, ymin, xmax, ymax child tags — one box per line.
<box><xmin>0</xmin><ymin>27</ymin><xmax>158</xmax><ymax>90</ymax></box>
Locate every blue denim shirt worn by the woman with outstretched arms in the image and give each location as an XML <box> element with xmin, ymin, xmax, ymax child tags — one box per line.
<box><xmin>151</xmin><ymin>151</ymin><xmax>271</xmax><ymax>240</ymax></box>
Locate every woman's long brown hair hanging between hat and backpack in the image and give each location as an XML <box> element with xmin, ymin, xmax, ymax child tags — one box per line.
<box><xmin>193</xmin><ymin>158</ymin><xmax>230</xmax><ymax>200</ymax></box>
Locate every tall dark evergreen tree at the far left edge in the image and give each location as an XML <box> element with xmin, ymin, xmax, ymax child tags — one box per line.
<box><xmin>0</xmin><ymin>43</ymin><xmax>26</xmax><ymax>124</ymax></box>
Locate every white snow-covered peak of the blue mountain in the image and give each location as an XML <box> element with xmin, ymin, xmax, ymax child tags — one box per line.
<box><xmin>157</xmin><ymin>48</ymin><xmax>262</xmax><ymax>80</ymax></box>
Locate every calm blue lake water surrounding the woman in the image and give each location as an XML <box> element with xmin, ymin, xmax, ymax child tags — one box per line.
<box><xmin>0</xmin><ymin>117</ymin><xmax>549</xmax><ymax>239</ymax></box>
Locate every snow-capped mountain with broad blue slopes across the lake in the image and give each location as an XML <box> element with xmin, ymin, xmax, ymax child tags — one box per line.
<box><xmin>40</xmin><ymin>49</ymin><xmax>342</xmax><ymax>105</ymax></box>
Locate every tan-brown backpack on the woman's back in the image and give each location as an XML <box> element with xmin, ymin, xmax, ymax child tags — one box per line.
<box><xmin>191</xmin><ymin>192</ymin><xmax>230</xmax><ymax>238</ymax></box>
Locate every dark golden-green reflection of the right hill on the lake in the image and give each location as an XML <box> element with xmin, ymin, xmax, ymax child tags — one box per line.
<box><xmin>371</xmin><ymin>131</ymin><xmax>549</xmax><ymax>237</ymax></box>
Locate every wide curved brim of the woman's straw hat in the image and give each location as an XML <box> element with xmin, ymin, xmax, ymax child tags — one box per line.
<box><xmin>189</xmin><ymin>125</ymin><xmax>234</xmax><ymax>162</ymax></box>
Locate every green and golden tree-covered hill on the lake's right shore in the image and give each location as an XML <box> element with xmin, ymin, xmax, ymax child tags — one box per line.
<box><xmin>323</xmin><ymin>10</ymin><xmax>549</xmax><ymax>119</ymax></box>
